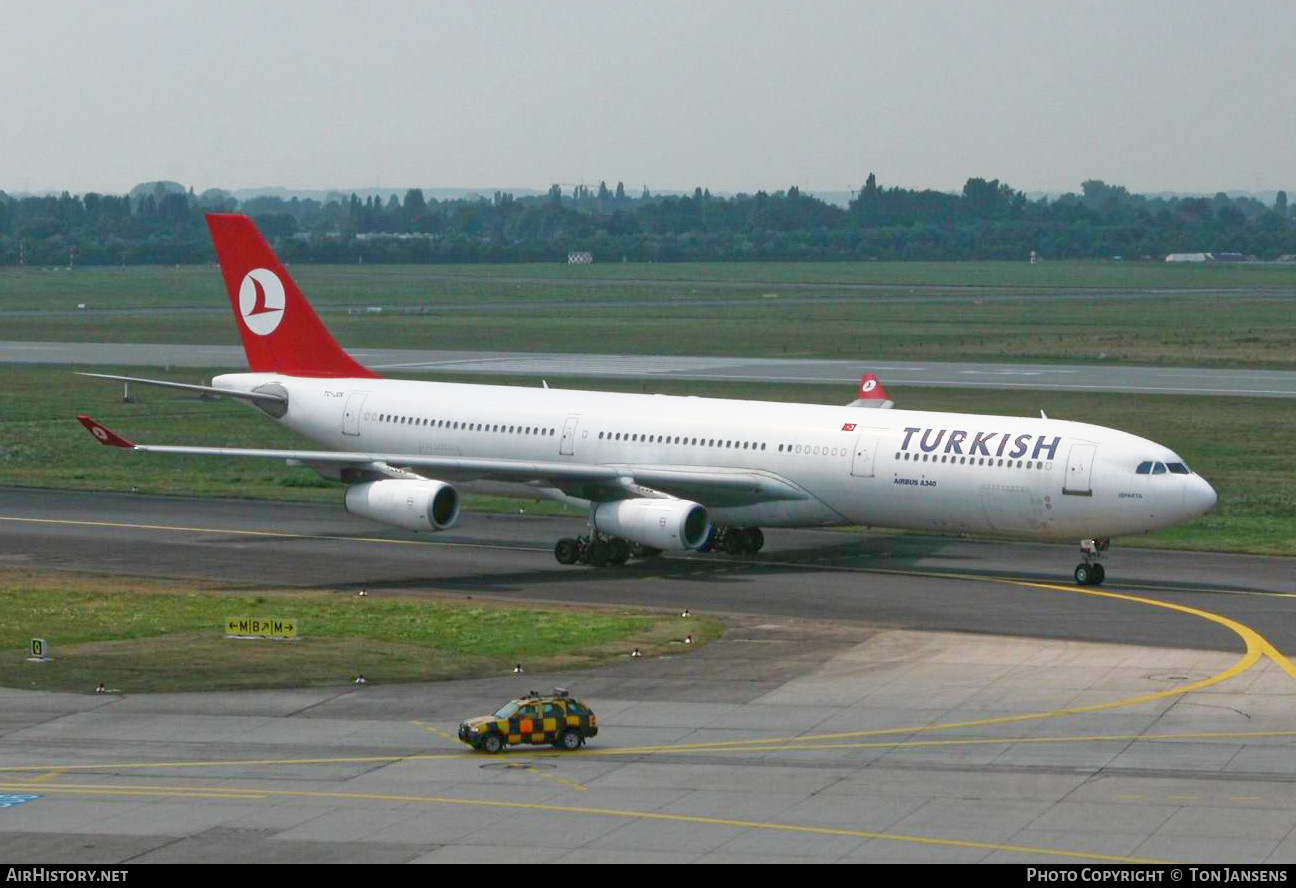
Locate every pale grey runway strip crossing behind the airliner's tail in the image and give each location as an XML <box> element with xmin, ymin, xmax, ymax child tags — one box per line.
<box><xmin>0</xmin><ymin>342</ymin><xmax>1296</xmax><ymax>398</ymax></box>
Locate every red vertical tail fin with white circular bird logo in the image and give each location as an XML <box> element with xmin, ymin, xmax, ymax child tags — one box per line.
<box><xmin>207</xmin><ymin>213</ymin><xmax>377</xmax><ymax>379</ymax></box>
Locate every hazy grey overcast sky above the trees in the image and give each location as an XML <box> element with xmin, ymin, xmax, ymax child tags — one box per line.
<box><xmin>0</xmin><ymin>0</ymin><xmax>1296</xmax><ymax>192</ymax></box>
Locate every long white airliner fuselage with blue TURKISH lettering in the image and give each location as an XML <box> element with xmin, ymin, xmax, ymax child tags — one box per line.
<box><xmin>213</xmin><ymin>373</ymin><xmax>1216</xmax><ymax>539</ymax></box>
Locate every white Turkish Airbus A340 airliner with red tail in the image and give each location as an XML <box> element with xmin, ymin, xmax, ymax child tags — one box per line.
<box><xmin>79</xmin><ymin>214</ymin><xmax>1216</xmax><ymax>585</ymax></box>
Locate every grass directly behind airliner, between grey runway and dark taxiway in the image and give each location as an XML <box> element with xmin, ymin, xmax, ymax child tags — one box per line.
<box><xmin>0</xmin><ymin>367</ymin><xmax>1296</xmax><ymax>555</ymax></box>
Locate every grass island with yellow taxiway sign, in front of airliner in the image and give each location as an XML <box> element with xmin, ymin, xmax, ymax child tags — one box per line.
<box><xmin>0</xmin><ymin>572</ymin><xmax>723</xmax><ymax>692</ymax></box>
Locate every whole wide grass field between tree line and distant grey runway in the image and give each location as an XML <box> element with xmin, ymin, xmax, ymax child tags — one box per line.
<box><xmin>0</xmin><ymin>262</ymin><xmax>1296</xmax><ymax>368</ymax></box>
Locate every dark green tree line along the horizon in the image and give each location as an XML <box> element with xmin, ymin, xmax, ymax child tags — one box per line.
<box><xmin>0</xmin><ymin>174</ymin><xmax>1296</xmax><ymax>266</ymax></box>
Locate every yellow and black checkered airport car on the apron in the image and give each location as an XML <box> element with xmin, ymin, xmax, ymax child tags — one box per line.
<box><xmin>459</xmin><ymin>687</ymin><xmax>599</xmax><ymax>753</ymax></box>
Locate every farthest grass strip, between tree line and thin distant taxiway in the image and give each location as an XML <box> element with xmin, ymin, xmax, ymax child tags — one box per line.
<box><xmin>0</xmin><ymin>261</ymin><xmax>1296</xmax><ymax>309</ymax></box>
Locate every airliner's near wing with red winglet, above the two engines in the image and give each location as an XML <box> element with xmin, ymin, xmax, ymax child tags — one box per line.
<box><xmin>76</xmin><ymin>415</ymin><xmax>809</xmax><ymax>506</ymax></box>
